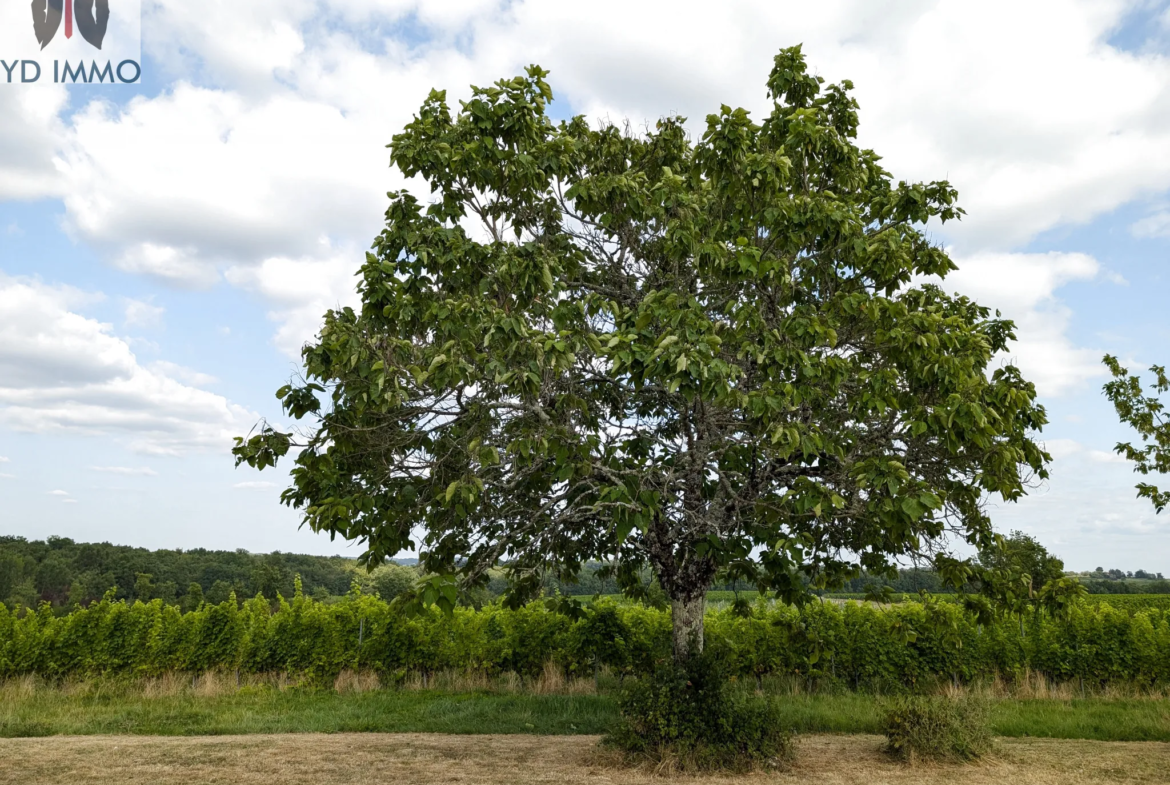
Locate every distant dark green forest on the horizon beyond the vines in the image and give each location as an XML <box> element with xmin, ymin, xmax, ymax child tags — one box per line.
<box><xmin>0</xmin><ymin>536</ymin><xmax>1170</xmax><ymax>612</ymax></box>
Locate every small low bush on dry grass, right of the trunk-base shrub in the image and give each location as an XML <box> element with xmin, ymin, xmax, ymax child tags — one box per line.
<box><xmin>885</xmin><ymin>695</ymin><xmax>991</xmax><ymax>762</ymax></box>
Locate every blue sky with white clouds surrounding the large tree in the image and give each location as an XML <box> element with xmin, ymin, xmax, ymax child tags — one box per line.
<box><xmin>0</xmin><ymin>0</ymin><xmax>1170</xmax><ymax>573</ymax></box>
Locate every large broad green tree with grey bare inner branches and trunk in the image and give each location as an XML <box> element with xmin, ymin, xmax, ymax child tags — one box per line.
<box><xmin>235</xmin><ymin>47</ymin><xmax>1047</xmax><ymax>659</ymax></box>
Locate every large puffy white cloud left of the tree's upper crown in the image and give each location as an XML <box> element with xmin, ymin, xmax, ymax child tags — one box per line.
<box><xmin>61</xmin><ymin>83</ymin><xmax>390</xmax><ymax>287</ymax></box>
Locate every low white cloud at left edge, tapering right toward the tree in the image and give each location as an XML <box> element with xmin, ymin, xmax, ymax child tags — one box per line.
<box><xmin>0</xmin><ymin>275</ymin><xmax>256</xmax><ymax>455</ymax></box>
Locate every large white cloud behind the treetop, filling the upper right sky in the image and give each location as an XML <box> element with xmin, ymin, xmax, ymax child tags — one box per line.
<box><xmin>477</xmin><ymin>0</ymin><xmax>1170</xmax><ymax>249</ymax></box>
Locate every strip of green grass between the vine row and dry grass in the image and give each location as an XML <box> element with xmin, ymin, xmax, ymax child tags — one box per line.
<box><xmin>0</xmin><ymin>689</ymin><xmax>1170</xmax><ymax>742</ymax></box>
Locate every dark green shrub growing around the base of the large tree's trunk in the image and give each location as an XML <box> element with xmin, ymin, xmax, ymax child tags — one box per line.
<box><xmin>606</xmin><ymin>654</ymin><xmax>793</xmax><ymax>770</ymax></box>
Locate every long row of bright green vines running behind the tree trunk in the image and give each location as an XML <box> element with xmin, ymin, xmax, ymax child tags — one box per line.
<box><xmin>0</xmin><ymin>591</ymin><xmax>1170</xmax><ymax>690</ymax></box>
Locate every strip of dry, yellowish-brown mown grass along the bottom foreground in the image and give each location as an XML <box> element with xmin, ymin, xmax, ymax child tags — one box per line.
<box><xmin>0</xmin><ymin>734</ymin><xmax>1170</xmax><ymax>785</ymax></box>
